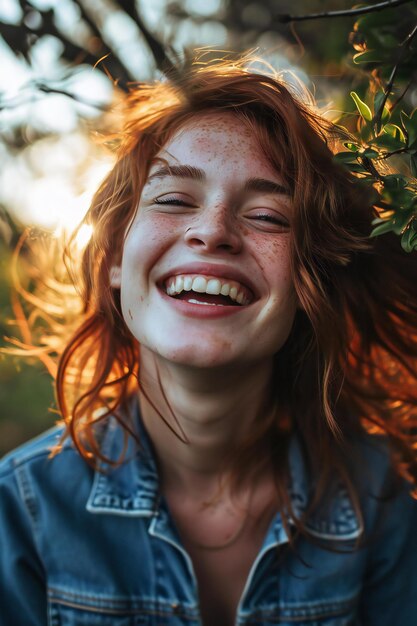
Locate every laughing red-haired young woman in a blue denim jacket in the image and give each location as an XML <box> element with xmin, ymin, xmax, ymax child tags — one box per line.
<box><xmin>0</xmin><ymin>54</ymin><xmax>417</xmax><ymax>626</ymax></box>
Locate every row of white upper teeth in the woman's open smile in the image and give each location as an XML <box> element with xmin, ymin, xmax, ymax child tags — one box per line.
<box><xmin>165</xmin><ymin>275</ymin><xmax>251</xmax><ymax>305</ymax></box>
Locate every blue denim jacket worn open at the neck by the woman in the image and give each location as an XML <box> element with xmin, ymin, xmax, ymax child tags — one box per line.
<box><xmin>0</xmin><ymin>408</ymin><xmax>417</xmax><ymax>626</ymax></box>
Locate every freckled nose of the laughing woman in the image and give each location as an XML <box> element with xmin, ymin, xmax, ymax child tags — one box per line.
<box><xmin>184</xmin><ymin>206</ymin><xmax>242</xmax><ymax>254</ymax></box>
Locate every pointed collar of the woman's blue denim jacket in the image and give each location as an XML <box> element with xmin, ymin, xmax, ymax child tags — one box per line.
<box><xmin>87</xmin><ymin>408</ymin><xmax>363</xmax><ymax>541</ymax></box>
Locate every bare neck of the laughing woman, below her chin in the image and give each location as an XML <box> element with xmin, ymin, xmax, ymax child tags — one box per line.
<box><xmin>139</xmin><ymin>348</ymin><xmax>272</xmax><ymax>497</ymax></box>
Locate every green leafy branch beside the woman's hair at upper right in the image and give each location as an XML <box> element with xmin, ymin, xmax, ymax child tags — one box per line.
<box><xmin>335</xmin><ymin>6</ymin><xmax>417</xmax><ymax>252</ymax></box>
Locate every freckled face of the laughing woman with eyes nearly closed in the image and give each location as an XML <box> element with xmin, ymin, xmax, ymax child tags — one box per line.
<box><xmin>114</xmin><ymin>113</ymin><xmax>296</xmax><ymax>368</ymax></box>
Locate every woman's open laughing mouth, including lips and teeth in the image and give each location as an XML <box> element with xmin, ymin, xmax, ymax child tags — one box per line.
<box><xmin>163</xmin><ymin>274</ymin><xmax>253</xmax><ymax>306</ymax></box>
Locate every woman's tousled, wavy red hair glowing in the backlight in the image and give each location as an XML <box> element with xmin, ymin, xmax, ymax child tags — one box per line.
<box><xmin>10</xmin><ymin>52</ymin><xmax>417</xmax><ymax>532</ymax></box>
